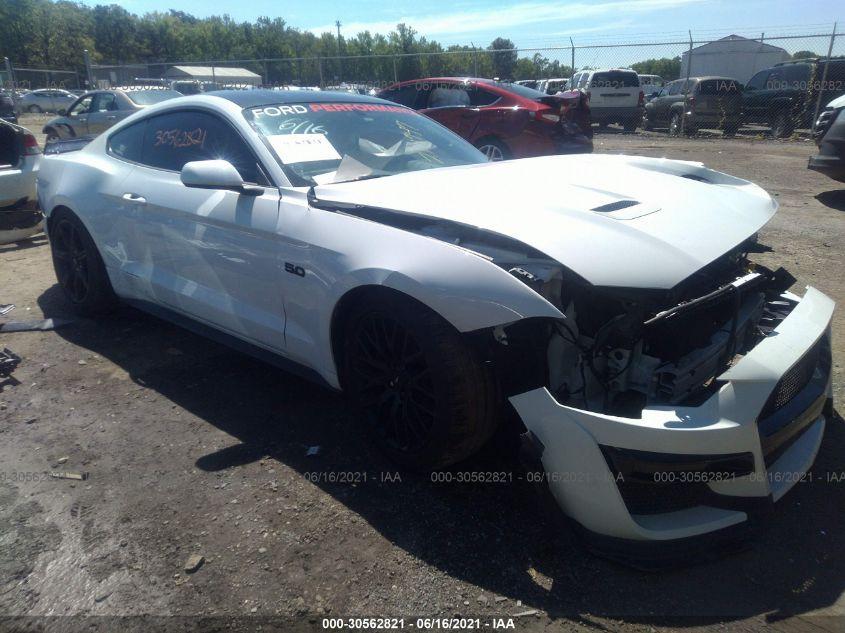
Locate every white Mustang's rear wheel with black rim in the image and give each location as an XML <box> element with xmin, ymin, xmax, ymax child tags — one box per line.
<box><xmin>49</xmin><ymin>209</ymin><xmax>117</xmax><ymax>316</ymax></box>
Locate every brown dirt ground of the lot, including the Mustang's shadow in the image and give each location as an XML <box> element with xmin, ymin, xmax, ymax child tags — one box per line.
<box><xmin>0</xmin><ymin>119</ymin><xmax>845</xmax><ymax>631</ymax></box>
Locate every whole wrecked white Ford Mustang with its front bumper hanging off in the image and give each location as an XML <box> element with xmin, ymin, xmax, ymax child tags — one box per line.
<box><xmin>38</xmin><ymin>91</ymin><xmax>833</xmax><ymax>558</ymax></box>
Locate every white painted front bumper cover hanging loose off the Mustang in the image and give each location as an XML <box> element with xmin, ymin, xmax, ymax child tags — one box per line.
<box><xmin>510</xmin><ymin>288</ymin><xmax>834</xmax><ymax>541</ymax></box>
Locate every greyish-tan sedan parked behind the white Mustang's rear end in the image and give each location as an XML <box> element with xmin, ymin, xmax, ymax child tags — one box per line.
<box><xmin>43</xmin><ymin>88</ymin><xmax>182</xmax><ymax>143</ymax></box>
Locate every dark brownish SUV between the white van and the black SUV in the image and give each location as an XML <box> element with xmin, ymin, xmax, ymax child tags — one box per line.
<box><xmin>643</xmin><ymin>77</ymin><xmax>742</xmax><ymax>136</ymax></box>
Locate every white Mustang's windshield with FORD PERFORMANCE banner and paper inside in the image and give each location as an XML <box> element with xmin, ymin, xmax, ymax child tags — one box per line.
<box><xmin>244</xmin><ymin>102</ymin><xmax>487</xmax><ymax>186</ymax></box>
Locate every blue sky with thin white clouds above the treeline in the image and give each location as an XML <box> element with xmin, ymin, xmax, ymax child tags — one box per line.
<box><xmin>76</xmin><ymin>0</ymin><xmax>845</xmax><ymax>47</ymax></box>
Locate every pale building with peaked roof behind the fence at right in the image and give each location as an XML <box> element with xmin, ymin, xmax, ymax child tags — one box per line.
<box><xmin>681</xmin><ymin>35</ymin><xmax>790</xmax><ymax>83</ymax></box>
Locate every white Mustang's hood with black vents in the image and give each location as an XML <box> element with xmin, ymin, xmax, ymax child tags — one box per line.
<box><xmin>314</xmin><ymin>155</ymin><xmax>777</xmax><ymax>289</ymax></box>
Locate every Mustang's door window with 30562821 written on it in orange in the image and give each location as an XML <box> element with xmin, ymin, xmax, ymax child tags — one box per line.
<box><xmin>141</xmin><ymin>110</ymin><xmax>266</xmax><ymax>184</ymax></box>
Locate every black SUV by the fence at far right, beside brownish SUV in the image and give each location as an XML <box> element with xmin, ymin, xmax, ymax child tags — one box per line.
<box><xmin>742</xmin><ymin>57</ymin><xmax>845</xmax><ymax>138</ymax></box>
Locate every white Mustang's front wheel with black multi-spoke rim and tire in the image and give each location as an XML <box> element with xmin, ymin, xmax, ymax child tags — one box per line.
<box><xmin>343</xmin><ymin>292</ymin><xmax>498</xmax><ymax>471</ymax></box>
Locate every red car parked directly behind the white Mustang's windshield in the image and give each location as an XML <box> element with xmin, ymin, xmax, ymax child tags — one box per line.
<box><xmin>378</xmin><ymin>77</ymin><xmax>593</xmax><ymax>160</ymax></box>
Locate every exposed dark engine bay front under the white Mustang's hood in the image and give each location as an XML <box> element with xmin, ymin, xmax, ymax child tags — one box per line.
<box><xmin>474</xmin><ymin>236</ymin><xmax>794</xmax><ymax>417</ymax></box>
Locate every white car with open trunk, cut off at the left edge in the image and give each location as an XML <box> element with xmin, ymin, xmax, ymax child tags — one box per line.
<box><xmin>0</xmin><ymin>120</ymin><xmax>43</xmax><ymax>244</ymax></box>
